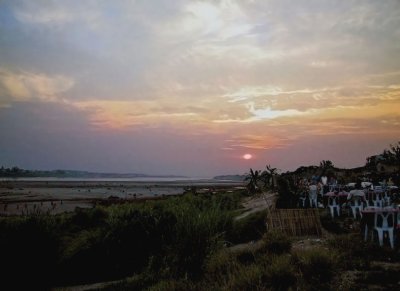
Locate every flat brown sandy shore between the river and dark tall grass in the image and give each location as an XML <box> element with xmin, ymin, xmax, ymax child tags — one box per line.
<box><xmin>0</xmin><ymin>180</ymin><xmax>243</xmax><ymax>215</ymax></box>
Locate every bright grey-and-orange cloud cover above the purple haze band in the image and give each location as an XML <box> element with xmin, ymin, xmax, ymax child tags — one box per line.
<box><xmin>0</xmin><ymin>0</ymin><xmax>400</xmax><ymax>175</ymax></box>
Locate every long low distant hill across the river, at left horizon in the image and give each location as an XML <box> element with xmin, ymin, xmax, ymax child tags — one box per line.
<box><xmin>0</xmin><ymin>167</ymin><xmax>185</xmax><ymax>178</ymax></box>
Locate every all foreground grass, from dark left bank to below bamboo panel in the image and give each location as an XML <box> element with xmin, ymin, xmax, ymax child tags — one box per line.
<box><xmin>0</xmin><ymin>188</ymin><xmax>400</xmax><ymax>290</ymax></box>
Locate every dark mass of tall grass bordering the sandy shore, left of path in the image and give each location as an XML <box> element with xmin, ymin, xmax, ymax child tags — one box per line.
<box><xmin>0</xmin><ymin>193</ymin><xmax>247</xmax><ymax>290</ymax></box>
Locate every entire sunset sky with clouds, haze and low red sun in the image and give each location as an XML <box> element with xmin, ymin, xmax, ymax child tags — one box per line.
<box><xmin>0</xmin><ymin>0</ymin><xmax>400</xmax><ymax>177</ymax></box>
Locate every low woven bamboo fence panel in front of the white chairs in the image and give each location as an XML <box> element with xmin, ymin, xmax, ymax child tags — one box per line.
<box><xmin>267</xmin><ymin>208</ymin><xmax>322</xmax><ymax>236</ymax></box>
